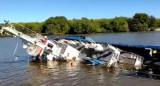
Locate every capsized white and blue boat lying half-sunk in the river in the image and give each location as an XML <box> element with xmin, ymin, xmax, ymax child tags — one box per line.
<box><xmin>0</xmin><ymin>22</ymin><xmax>160</xmax><ymax>67</ymax></box>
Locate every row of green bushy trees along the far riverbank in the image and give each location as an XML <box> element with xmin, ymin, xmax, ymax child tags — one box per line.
<box><xmin>2</xmin><ymin>13</ymin><xmax>160</xmax><ymax>35</ymax></box>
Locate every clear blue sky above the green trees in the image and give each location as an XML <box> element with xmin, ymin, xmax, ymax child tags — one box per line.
<box><xmin>0</xmin><ymin>0</ymin><xmax>160</xmax><ymax>23</ymax></box>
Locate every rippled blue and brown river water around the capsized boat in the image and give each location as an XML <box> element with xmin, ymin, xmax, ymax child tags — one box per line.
<box><xmin>0</xmin><ymin>32</ymin><xmax>160</xmax><ymax>86</ymax></box>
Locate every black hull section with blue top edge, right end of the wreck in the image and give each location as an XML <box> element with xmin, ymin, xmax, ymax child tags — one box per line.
<box><xmin>113</xmin><ymin>44</ymin><xmax>160</xmax><ymax>65</ymax></box>
